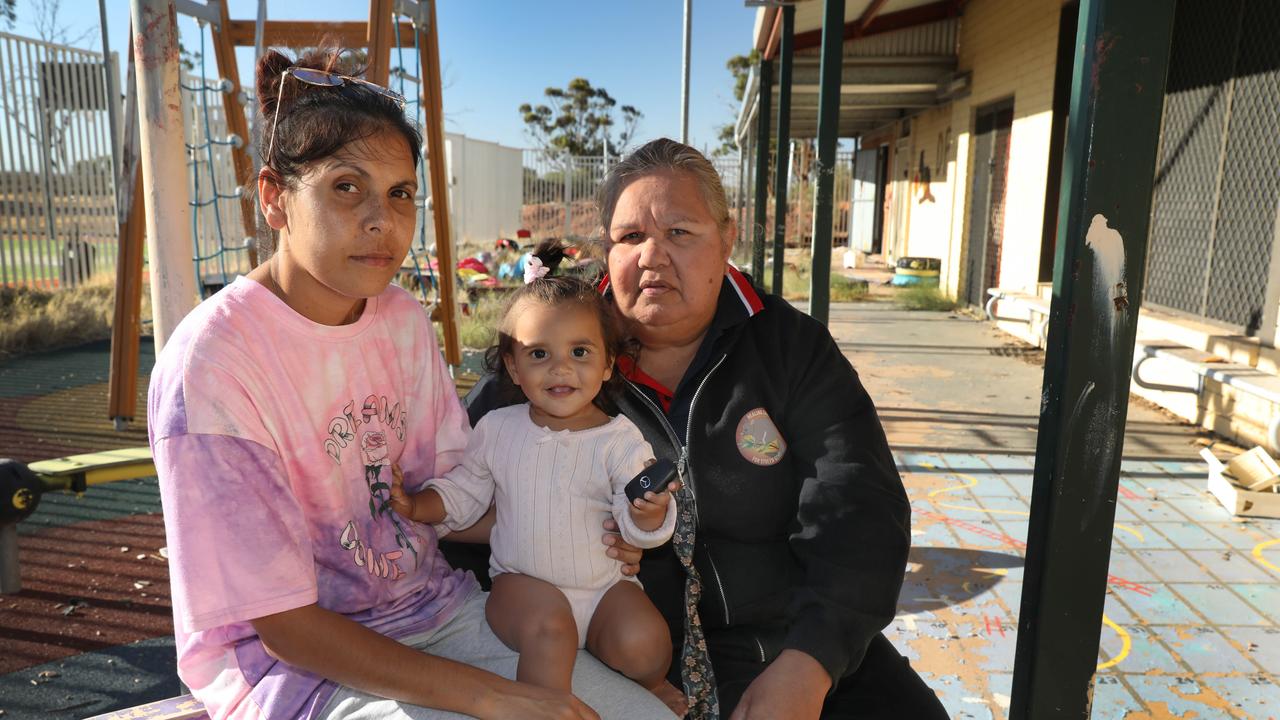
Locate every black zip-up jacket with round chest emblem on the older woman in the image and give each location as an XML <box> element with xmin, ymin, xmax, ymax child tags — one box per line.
<box><xmin>460</xmin><ymin>270</ymin><xmax>910</xmax><ymax>688</ymax></box>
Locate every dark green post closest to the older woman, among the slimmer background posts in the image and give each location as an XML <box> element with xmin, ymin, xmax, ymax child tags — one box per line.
<box><xmin>809</xmin><ymin>0</ymin><xmax>845</xmax><ymax>325</ymax></box>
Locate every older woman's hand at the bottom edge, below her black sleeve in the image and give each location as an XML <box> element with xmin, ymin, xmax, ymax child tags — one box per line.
<box><xmin>730</xmin><ymin>650</ymin><xmax>831</xmax><ymax>720</ymax></box>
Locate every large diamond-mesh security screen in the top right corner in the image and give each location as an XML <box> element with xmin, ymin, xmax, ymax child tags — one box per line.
<box><xmin>1144</xmin><ymin>0</ymin><xmax>1280</xmax><ymax>334</ymax></box>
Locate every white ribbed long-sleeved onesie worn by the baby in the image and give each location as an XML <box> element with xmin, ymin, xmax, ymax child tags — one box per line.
<box><xmin>428</xmin><ymin>404</ymin><xmax>676</xmax><ymax>647</ymax></box>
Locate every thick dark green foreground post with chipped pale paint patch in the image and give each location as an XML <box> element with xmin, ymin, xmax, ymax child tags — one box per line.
<box><xmin>1010</xmin><ymin>0</ymin><xmax>1174</xmax><ymax>720</ymax></box>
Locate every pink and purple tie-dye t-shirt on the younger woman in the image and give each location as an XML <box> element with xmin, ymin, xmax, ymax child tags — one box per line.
<box><xmin>147</xmin><ymin>278</ymin><xmax>476</xmax><ymax>720</ymax></box>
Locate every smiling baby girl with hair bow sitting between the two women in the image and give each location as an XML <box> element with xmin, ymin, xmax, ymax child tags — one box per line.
<box><xmin>392</xmin><ymin>242</ymin><xmax>682</xmax><ymax>714</ymax></box>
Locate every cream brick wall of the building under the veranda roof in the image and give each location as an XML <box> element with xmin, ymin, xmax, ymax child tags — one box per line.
<box><xmin>901</xmin><ymin>0</ymin><xmax>1062</xmax><ymax>295</ymax></box>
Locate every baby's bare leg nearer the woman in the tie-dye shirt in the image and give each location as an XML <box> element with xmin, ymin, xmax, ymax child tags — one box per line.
<box><xmin>485</xmin><ymin>573</ymin><xmax>577</xmax><ymax>691</ymax></box>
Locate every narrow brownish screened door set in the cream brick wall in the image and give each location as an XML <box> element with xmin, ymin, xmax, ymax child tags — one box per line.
<box><xmin>965</xmin><ymin>104</ymin><xmax>1014</xmax><ymax>305</ymax></box>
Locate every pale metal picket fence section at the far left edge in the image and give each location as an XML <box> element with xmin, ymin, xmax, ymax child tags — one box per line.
<box><xmin>0</xmin><ymin>33</ymin><xmax>119</xmax><ymax>288</ymax></box>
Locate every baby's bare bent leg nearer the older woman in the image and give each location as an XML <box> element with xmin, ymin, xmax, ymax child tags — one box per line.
<box><xmin>586</xmin><ymin>580</ymin><xmax>671</xmax><ymax>691</ymax></box>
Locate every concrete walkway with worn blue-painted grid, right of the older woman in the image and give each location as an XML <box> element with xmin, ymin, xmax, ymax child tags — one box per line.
<box><xmin>831</xmin><ymin>291</ymin><xmax>1280</xmax><ymax>720</ymax></box>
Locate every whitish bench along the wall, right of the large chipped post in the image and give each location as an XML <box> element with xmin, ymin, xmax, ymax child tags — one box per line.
<box><xmin>1132</xmin><ymin>342</ymin><xmax>1280</xmax><ymax>452</ymax></box>
